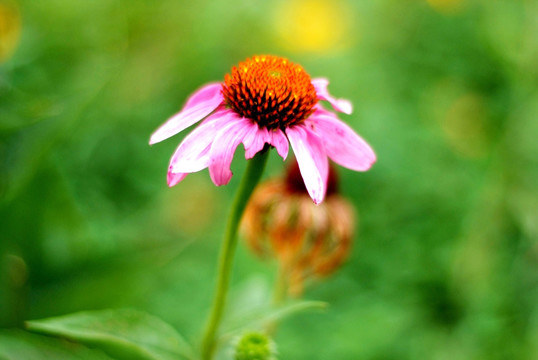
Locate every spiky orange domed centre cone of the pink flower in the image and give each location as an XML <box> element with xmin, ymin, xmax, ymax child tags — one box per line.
<box><xmin>222</xmin><ymin>55</ymin><xmax>318</xmax><ymax>129</ymax></box>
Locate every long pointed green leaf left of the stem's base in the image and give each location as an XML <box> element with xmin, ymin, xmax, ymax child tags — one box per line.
<box><xmin>27</xmin><ymin>310</ymin><xmax>195</xmax><ymax>360</ymax></box>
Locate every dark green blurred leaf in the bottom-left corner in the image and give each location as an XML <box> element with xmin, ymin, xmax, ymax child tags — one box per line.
<box><xmin>0</xmin><ymin>329</ymin><xmax>112</xmax><ymax>360</ymax></box>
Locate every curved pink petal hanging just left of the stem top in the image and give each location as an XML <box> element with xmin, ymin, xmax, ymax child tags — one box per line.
<box><xmin>209</xmin><ymin>112</ymin><xmax>252</xmax><ymax>186</ymax></box>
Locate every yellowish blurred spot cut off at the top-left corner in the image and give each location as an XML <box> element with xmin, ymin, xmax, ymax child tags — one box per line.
<box><xmin>0</xmin><ymin>0</ymin><xmax>21</xmax><ymax>63</ymax></box>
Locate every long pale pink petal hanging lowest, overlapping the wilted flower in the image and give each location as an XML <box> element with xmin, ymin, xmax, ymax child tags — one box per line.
<box><xmin>286</xmin><ymin>125</ymin><xmax>329</xmax><ymax>204</ymax></box>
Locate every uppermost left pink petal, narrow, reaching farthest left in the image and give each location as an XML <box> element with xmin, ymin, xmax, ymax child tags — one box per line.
<box><xmin>149</xmin><ymin>83</ymin><xmax>224</xmax><ymax>145</ymax></box>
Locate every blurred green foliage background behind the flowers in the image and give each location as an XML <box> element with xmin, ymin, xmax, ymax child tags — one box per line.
<box><xmin>0</xmin><ymin>0</ymin><xmax>538</xmax><ymax>360</ymax></box>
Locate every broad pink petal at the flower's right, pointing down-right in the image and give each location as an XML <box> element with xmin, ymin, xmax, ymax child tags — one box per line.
<box><xmin>308</xmin><ymin>112</ymin><xmax>376</xmax><ymax>171</ymax></box>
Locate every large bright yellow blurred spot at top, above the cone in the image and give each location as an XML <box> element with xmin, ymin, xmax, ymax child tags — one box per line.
<box><xmin>274</xmin><ymin>0</ymin><xmax>356</xmax><ymax>53</ymax></box>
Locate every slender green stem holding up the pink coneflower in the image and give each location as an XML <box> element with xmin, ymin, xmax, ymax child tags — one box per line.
<box><xmin>201</xmin><ymin>149</ymin><xmax>269</xmax><ymax>360</ymax></box>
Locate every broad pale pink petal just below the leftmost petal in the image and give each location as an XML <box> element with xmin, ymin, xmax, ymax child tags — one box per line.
<box><xmin>168</xmin><ymin>109</ymin><xmax>232</xmax><ymax>173</ymax></box>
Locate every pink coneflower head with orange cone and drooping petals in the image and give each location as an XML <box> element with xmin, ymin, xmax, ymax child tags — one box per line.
<box><xmin>150</xmin><ymin>55</ymin><xmax>376</xmax><ymax>204</ymax></box>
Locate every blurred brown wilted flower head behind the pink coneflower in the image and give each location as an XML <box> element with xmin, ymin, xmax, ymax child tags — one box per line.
<box><xmin>242</xmin><ymin>163</ymin><xmax>354</xmax><ymax>295</ymax></box>
